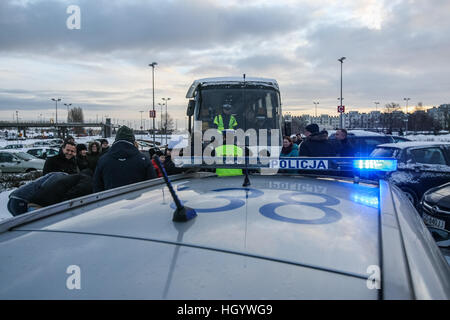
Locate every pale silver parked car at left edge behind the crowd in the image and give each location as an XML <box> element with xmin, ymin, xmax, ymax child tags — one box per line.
<box><xmin>0</xmin><ymin>151</ymin><xmax>45</xmax><ymax>173</ymax></box>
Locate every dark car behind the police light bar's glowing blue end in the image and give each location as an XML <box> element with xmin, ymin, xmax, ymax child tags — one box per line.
<box><xmin>328</xmin><ymin>130</ymin><xmax>395</xmax><ymax>157</ymax></box>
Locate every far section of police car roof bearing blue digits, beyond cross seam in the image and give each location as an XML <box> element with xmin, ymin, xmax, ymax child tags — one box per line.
<box><xmin>7</xmin><ymin>176</ymin><xmax>379</xmax><ymax>278</ymax></box>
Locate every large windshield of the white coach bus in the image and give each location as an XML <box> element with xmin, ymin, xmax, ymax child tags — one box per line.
<box><xmin>196</xmin><ymin>85</ymin><xmax>280</xmax><ymax>131</ymax></box>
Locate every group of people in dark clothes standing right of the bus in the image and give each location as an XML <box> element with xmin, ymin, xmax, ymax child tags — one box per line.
<box><xmin>280</xmin><ymin>123</ymin><xmax>355</xmax><ymax>157</ymax></box>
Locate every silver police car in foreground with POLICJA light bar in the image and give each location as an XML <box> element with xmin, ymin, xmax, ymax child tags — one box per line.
<box><xmin>0</xmin><ymin>158</ymin><xmax>450</xmax><ymax>300</ymax></box>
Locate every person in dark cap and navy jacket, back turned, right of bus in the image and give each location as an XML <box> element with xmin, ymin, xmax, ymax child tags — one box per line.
<box><xmin>298</xmin><ymin>123</ymin><xmax>336</xmax><ymax>157</ymax></box>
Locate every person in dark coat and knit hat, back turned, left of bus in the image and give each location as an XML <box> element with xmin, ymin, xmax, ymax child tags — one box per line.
<box><xmin>94</xmin><ymin>126</ymin><xmax>156</xmax><ymax>192</ymax></box>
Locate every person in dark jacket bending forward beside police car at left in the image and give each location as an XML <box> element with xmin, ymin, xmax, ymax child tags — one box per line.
<box><xmin>8</xmin><ymin>169</ymin><xmax>92</xmax><ymax>216</ymax></box>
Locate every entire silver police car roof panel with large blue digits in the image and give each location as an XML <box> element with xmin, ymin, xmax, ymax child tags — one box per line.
<box><xmin>0</xmin><ymin>176</ymin><xmax>380</xmax><ymax>299</ymax></box>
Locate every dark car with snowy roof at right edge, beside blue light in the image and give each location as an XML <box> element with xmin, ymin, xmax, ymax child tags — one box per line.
<box><xmin>370</xmin><ymin>141</ymin><xmax>450</xmax><ymax>206</ymax></box>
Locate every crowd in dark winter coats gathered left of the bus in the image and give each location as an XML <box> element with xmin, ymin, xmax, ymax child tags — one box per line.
<box><xmin>8</xmin><ymin>126</ymin><xmax>180</xmax><ymax>216</ymax></box>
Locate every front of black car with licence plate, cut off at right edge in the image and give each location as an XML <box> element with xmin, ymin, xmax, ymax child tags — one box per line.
<box><xmin>420</xmin><ymin>183</ymin><xmax>450</xmax><ymax>242</ymax></box>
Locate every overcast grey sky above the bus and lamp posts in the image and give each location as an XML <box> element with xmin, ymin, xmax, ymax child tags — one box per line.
<box><xmin>0</xmin><ymin>0</ymin><xmax>450</xmax><ymax>127</ymax></box>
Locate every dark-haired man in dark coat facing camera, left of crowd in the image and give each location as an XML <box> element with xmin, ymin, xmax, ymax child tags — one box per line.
<box><xmin>43</xmin><ymin>141</ymin><xmax>78</xmax><ymax>175</ymax></box>
